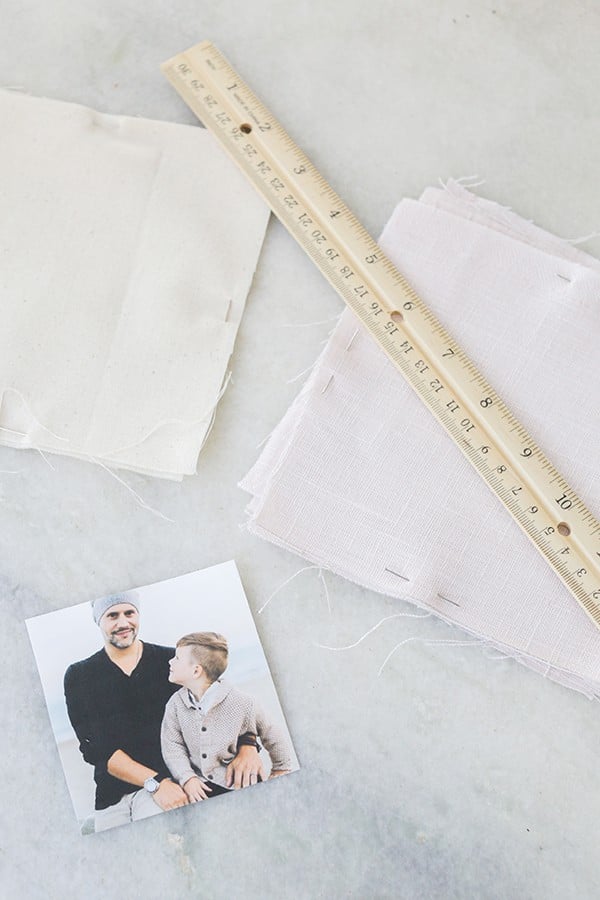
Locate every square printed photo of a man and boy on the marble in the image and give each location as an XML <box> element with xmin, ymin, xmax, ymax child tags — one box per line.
<box><xmin>26</xmin><ymin>562</ymin><xmax>298</xmax><ymax>834</ymax></box>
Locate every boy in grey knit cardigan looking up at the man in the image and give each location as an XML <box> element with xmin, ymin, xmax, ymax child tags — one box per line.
<box><xmin>161</xmin><ymin>631</ymin><xmax>294</xmax><ymax>803</ymax></box>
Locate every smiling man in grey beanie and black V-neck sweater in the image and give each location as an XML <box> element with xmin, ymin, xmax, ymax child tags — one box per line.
<box><xmin>64</xmin><ymin>592</ymin><xmax>262</xmax><ymax>831</ymax></box>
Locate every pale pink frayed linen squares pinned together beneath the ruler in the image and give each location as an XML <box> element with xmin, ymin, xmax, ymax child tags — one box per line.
<box><xmin>242</xmin><ymin>183</ymin><xmax>600</xmax><ymax>697</ymax></box>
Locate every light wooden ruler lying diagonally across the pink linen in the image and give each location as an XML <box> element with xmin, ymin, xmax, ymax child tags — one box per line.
<box><xmin>161</xmin><ymin>41</ymin><xmax>600</xmax><ymax>628</ymax></box>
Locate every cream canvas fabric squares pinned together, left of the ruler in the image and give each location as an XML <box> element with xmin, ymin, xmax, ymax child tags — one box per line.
<box><xmin>0</xmin><ymin>91</ymin><xmax>268</xmax><ymax>480</ymax></box>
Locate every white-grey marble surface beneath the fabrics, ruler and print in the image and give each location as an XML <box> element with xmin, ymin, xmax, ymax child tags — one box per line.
<box><xmin>0</xmin><ymin>0</ymin><xmax>600</xmax><ymax>900</ymax></box>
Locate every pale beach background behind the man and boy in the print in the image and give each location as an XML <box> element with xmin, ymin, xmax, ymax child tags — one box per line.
<box><xmin>26</xmin><ymin>562</ymin><xmax>298</xmax><ymax>826</ymax></box>
